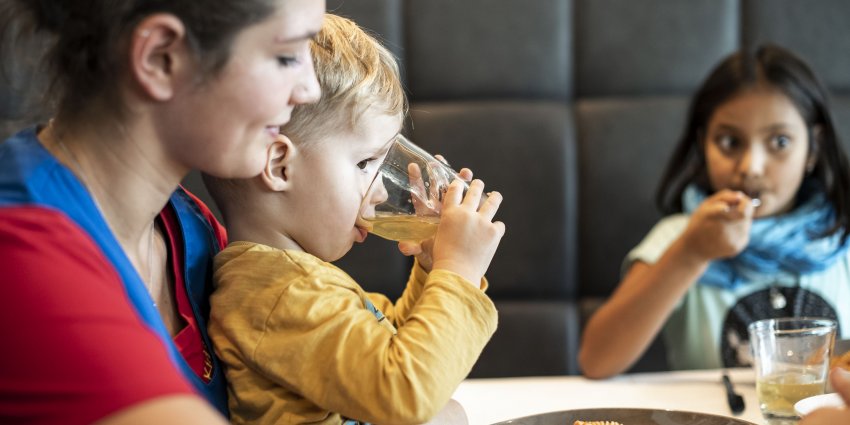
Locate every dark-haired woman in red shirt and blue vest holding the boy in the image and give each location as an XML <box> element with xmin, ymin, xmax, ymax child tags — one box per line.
<box><xmin>0</xmin><ymin>0</ymin><xmax>324</xmax><ymax>424</ymax></box>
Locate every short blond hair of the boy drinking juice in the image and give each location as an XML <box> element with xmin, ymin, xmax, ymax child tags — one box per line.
<box><xmin>281</xmin><ymin>14</ymin><xmax>407</xmax><ymax>145</ymax></box>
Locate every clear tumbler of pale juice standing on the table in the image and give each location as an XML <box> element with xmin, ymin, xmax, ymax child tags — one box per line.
<box><xmin>748</xmin><ymin>317</ymin><xmax>837</xmax><ymax>424</ymax></box>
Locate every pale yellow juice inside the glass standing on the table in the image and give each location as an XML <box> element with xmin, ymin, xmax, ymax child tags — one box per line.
<box><xmin>756</xmin><ymin>373</ymin><xmax>826</xmax><ymax>418</ymax></box>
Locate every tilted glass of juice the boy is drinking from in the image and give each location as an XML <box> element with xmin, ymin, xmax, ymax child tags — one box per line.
<box><xmin>358</xmin><ymin>134</ymin><xmax>486</xmax><ymax>241</ymax></box>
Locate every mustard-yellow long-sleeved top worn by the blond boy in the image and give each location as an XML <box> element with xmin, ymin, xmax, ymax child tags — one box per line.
<box><xmin>209</xmin><ymin>242</ymin><xmax>497</xmax><ymax>424</ymax></box>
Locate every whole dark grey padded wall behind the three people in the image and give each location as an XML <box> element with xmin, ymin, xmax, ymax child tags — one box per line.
<box><xmin>0</xmin><ymin>0</ymin><xmax>850</xmax><ymax>377</ymax></box>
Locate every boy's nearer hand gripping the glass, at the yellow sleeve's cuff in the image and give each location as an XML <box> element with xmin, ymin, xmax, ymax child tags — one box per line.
<box><xmin>431</xmin><ymin>180</ymin><xmax>505</xmax><ymax>287</ymax></box>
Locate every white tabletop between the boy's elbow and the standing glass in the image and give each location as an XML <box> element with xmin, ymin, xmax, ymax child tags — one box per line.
<box><xmin>453</xmin><ymin>368</ymin><xmax>767</xmax><ymax>425</ymax></box>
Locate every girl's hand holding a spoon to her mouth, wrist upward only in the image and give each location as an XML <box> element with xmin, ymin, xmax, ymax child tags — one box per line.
<box><xmin>682</xmin><ymin>190</ymin><xmax>755</xmax><ymax>261</ymax></box>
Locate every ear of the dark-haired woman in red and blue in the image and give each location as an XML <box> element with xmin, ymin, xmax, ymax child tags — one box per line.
<box><xmin>129</xmin><ymin>13</ymin><xmax>188</xmax><ymax>101</ymax></box>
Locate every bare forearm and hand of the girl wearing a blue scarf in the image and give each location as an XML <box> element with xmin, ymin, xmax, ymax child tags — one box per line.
<box><xmin>579</xmin><ymin>190</ymin><xmax>753</xmax><ymax>378</ymax></box>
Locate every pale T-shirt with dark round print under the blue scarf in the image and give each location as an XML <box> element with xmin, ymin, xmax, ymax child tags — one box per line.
<box><xmin>623</xmin><ymin>214</ymin><xmax>850</xmax><ymax>369</ymax></box>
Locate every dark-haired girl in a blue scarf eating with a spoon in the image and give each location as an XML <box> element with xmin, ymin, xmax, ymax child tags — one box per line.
<box><xmin>579</xmin><ymin>46</ymin><xmax>850</xmax><ymax>378</ymax></box>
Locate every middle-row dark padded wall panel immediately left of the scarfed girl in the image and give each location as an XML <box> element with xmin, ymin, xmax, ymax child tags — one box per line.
<box><xmin>577</xmin><ymin>97</ymin><xmax>687</xmax><ymax>296</ymax></box>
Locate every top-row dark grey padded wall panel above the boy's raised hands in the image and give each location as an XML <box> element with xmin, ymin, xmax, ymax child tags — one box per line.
<box><xmin>406</xmin><ymin>0</ymin><xmax>573</xmax><ymax>101</ymax></box>
